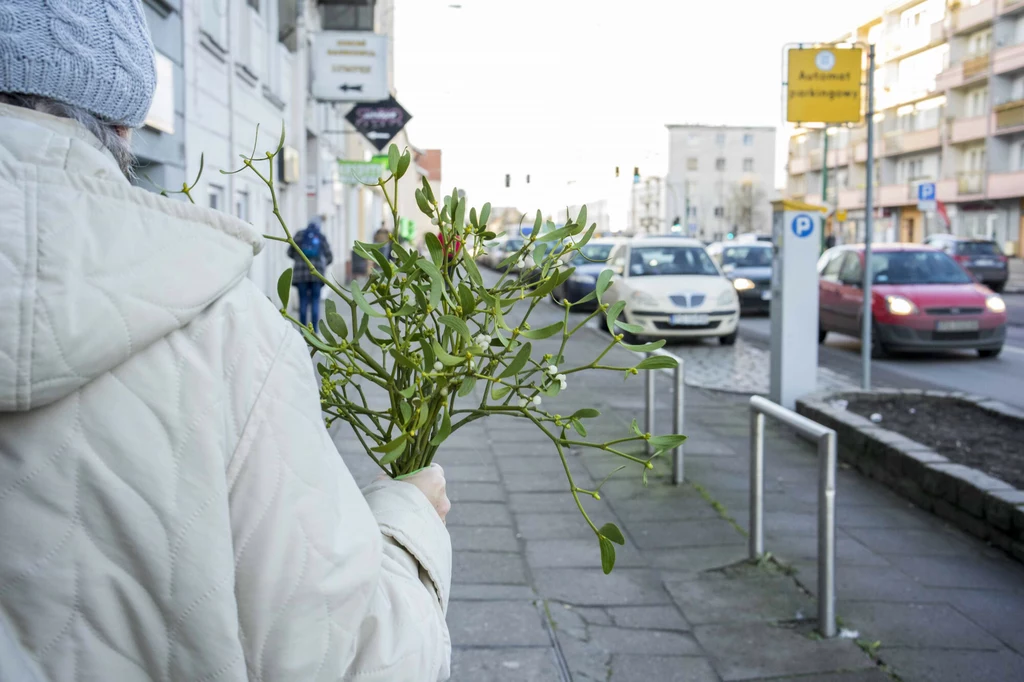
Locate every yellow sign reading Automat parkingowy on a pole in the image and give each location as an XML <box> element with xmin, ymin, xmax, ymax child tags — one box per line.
<box><xmin>785</xmin><ymin>47</ymin><xmax>862</xmax><ymax>123</ymax></box>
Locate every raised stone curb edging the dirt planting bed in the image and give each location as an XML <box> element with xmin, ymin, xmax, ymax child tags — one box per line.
<box><xmin>797</xmin><ymin>389</ymin><xmax>1024</xmax><ymax>562</ymax></box>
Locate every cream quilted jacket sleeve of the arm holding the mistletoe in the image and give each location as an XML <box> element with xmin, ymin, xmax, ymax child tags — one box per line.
<box><xmin>227</xmin><ymin>329</ymin><xmax>452</xmax><ymax>682</ymax></box>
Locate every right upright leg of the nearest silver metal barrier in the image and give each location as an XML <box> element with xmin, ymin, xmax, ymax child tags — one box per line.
<box><xmin>818</xmin><ymin>431</ymin><xmax>836</xmax><ymax>637</ymax></box>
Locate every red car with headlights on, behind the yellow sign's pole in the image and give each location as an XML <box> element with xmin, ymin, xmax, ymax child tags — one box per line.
<box><xmin>818</xmin><ymin>244</ymin><xmax>1007</xmax><ymax>357</ymax></box>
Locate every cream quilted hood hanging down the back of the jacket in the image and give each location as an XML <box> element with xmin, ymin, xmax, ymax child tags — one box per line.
<box><xmin>0</xmin><ymin>104</ymin><xmax>262</xmax><ymax>412</ymax></box>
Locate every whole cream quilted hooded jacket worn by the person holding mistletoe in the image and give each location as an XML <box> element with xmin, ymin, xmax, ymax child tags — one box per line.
<box><xmin>0</xmin><ymin>104</ymin><xmax>452</xmax><ymax>682</ymax></box>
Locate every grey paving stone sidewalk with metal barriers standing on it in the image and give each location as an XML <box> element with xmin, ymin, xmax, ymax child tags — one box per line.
<box><xmin>336</xmin><ymin>299</ymin><xmax>1024</xmax><ymax>682</ymax></box>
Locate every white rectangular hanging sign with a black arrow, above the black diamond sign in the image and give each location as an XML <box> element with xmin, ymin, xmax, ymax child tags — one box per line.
<box><xmin>310</xmin><ymin>31</ymin><xmax>388</xmax><ymax>101</ymax></box>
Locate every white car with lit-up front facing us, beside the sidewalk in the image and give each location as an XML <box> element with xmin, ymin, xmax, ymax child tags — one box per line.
<box><xmin>603</xmin><ymin>238</ymin><xmax>739</xmax><ymax>346</ymax></box>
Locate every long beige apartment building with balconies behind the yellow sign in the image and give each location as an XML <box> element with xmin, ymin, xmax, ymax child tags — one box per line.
<box><xmin>786</xmin><ymin>0</ymin><xmax>1024</xmax><ymax>255</ymax></box>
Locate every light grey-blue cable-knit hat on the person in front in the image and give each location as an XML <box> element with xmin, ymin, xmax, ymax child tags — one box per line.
<box><xmin>0</xmin><ymin>0</ymin><xmax>157</xmax><ymax>128</ymax></box>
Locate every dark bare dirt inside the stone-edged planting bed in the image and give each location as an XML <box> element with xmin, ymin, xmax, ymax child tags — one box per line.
<box><xmin>844</xmin><ymin>395</ymin><xmax>1024</xmax><ymax>489</ymax></box>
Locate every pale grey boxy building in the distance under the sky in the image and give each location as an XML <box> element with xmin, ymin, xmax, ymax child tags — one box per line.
<box><xmin>662</xmin><ymin>125</ymin><xmax>775</xmax><ymax>241</ymax></box>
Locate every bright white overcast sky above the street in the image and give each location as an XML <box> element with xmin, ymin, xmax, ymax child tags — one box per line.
<box><xmin>394</xmin><ymin>0</ymin><xmax>884</xmax><ymax>216</ymax></box>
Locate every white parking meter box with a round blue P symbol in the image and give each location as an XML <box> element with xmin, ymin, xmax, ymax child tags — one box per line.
<box><xmin>769</xmin><ymin>199</ymin><xmax>826</xmax><ymax>410</ymax></box>
